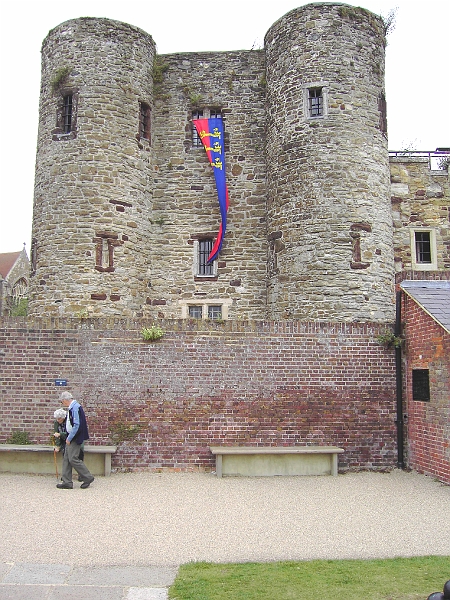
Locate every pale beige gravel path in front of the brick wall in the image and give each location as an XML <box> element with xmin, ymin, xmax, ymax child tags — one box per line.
<box><xmin>0</xmin><ymin>471</ymin><xmax>450</xmax><ymax>567</ymax></box>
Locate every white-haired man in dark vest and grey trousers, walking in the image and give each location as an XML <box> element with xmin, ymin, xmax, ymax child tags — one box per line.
<box><xmin>56</xmin><ymin>392</ymin><xmax>94</xmax><ymax>490</ymax></box>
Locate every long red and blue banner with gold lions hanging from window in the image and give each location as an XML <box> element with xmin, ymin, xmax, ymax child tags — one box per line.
<box><xmin>193</xmin><ymin>118</ymin><xmax>229</xmax><ymax>262</ymax></box>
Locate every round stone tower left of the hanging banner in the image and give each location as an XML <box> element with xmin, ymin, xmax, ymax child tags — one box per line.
<box><xmin>29</xmin><ymin>18</ymin><xmax>155</xmax><ymax>316</ymax></box>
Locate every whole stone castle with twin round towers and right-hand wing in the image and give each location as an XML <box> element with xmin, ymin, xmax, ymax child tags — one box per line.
<box><xmin>29</xmin><ymin>2</ymin><xmax>450</xmax><ymax>322</ymax></box>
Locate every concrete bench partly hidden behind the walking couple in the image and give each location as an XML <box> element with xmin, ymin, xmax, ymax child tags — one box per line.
<box><xmin>0</xmin><ymin>444</ymin><xmax>117</xmax><ymax>477</ymax></box>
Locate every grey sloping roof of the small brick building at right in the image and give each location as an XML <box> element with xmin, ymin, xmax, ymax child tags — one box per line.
<box><xmin>400</xmin><ymin>281</ymin><xmax>450</xmax><ymax>333</ymax></box>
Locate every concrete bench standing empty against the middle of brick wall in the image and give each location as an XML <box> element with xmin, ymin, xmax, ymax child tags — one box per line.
<box><xmin>210</xmin><ymin>446</ymin><xmax>344</xmax><ymax>477</ymax></box>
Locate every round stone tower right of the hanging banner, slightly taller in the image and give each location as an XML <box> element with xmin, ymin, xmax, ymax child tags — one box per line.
<box><xmin>265</xmin><ymin>2</ymin><xmax>394</xmax><ymax>322</ymax></box>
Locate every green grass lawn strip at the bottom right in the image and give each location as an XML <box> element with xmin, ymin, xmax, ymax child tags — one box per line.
<box><xmin>169</xmin><ymin>556</ymin><xmax>450</xmax><ymax>600</ymax></box>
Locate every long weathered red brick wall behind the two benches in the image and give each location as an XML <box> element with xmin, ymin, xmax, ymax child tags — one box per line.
<box><xmin>0</xmin><ymin>320</ymin><xmax>397</xmax><ymax>471</ymax></box>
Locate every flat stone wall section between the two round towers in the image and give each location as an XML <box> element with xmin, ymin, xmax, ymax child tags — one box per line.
<box><xmin>144</xmin><ymin>51</ymin><xmax>267</xmax><ymax>319</ymax></box>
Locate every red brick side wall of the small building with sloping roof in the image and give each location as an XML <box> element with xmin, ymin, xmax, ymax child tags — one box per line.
<box><xmin>402</xmin><ymin>294</ymin><xmax>450</xmax><ymax>483</ymax></box>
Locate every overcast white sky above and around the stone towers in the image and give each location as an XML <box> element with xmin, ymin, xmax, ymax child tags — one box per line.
<box><xmin>0</xmin><ymin>0</ymin><xmax>450</xmax><ymax>254</ymax></box>
